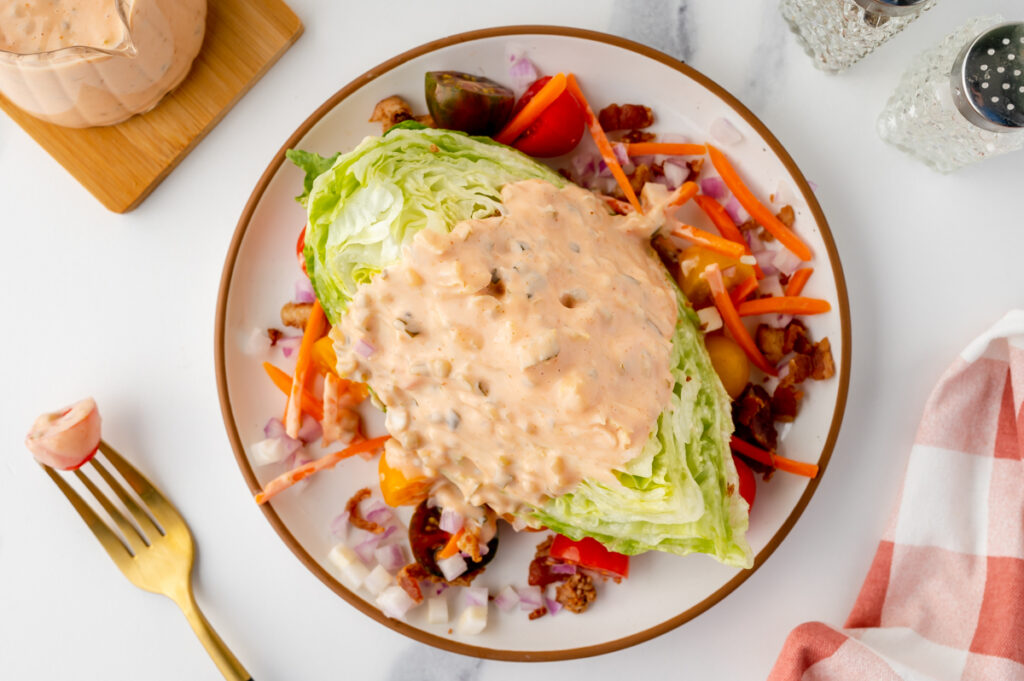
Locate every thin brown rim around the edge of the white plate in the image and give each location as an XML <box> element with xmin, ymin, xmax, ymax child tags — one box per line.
<box><xmin>214</xmin><ymin>26</ymin><xmax>851</xmax><ymax>662</ymax></box>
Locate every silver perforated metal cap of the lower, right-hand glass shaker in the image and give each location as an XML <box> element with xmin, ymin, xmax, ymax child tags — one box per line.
<box><xmin>950</xmin><ymin>22</ymin><xmax>1024</xmax><ymax>132</ymax></box>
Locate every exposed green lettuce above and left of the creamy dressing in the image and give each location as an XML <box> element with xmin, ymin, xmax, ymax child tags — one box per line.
<box><xmin>289</xmin><ymin>124</ymin><xmax>565</xmax><ymax>324</ymax></box>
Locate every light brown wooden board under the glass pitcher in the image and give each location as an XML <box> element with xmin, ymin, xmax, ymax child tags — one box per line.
<box><xmin>0</xmin><ymin>0</ymin><xmax>302</xmax><ymax>213</ymax></box>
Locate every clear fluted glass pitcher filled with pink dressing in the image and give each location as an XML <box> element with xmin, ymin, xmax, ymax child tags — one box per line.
<box><xmin>0</xmin><ymin>0</ymin><xmax>207</xmax><ymax>128</ymax></box>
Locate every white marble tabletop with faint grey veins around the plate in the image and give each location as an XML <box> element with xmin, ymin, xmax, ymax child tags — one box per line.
<box><xmin>0</xmin><ymin>0</ymin><xmax>1024</xmax><ymax>681</ymax></box>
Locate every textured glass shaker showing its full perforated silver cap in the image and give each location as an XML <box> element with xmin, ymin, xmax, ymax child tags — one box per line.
<box><xmin>878</xmin><ymin>16</ymin><xmax>1024</xmax><ymax>172</ymax></box>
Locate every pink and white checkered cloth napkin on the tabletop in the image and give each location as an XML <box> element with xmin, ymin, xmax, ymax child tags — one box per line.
<box><xmin>768</xmin><ymin>310</ymin><xmax>1024</xmax><ymax>681</ymax></box>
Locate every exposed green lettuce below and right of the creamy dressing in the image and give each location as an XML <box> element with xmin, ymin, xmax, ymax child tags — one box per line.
<box><xmin>530</xmin><ymin>293</ymin><xmax>753</xmax><ymax>567</ymax></box>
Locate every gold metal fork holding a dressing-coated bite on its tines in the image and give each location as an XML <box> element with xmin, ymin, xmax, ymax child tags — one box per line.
<box><xmin>43</xmin><ymin>441</ymin><xmax>252</xmax><ymax>681</ymax></box>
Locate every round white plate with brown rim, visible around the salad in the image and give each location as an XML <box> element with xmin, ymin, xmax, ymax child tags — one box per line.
<box><xmin>216</xmin><ymin>27</ymin><xmax>850</xmax><ymax>659</ymax></box>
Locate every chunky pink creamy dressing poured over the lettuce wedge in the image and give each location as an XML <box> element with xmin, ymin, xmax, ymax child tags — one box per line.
<box><xmin>332</xmin><ymin>180</ymin><xmax>678</xmax><ymax>513</ymax></box>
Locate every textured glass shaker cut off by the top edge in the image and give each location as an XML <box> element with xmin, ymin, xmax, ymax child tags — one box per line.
<box><xmin>779</xmin><ymin>0</ymin><xmax>936</xmax><ymax>74</ymax></box>
